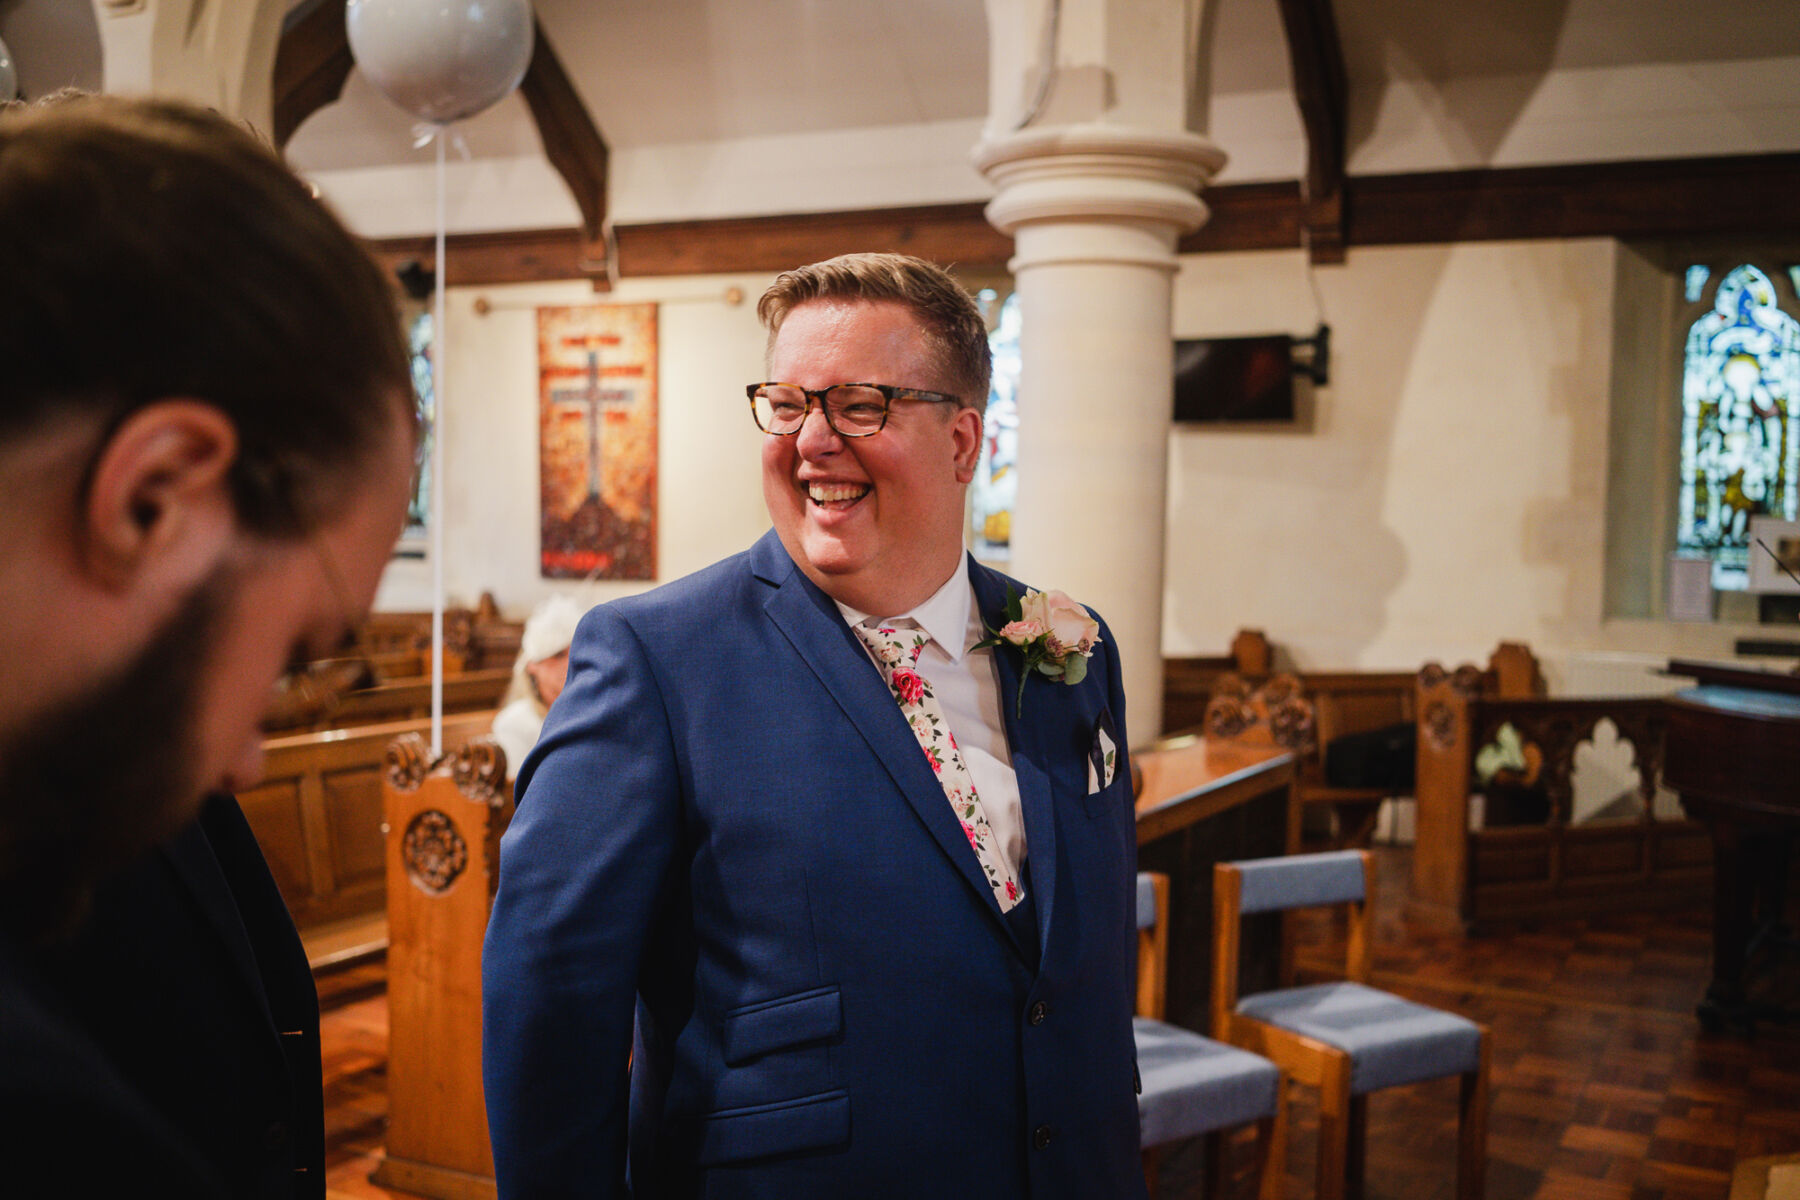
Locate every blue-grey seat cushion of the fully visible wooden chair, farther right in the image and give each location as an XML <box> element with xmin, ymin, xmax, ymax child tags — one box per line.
<box><xmin>1237</xmin><ymin>982</ymin><xmax>1481</xmax><ymax>1096</ymax></box>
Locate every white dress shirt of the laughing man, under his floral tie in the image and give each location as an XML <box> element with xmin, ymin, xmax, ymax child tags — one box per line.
<box><xmin>837</xmin><ymin>560</ymin><xmax>1026</xmax><ymax>880</ymax></box>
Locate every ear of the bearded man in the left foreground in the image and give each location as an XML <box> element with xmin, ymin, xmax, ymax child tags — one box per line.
<box><xmin>79</xmin><ymin>399</ymin><xmax>238</xmax><ymax>588</ymax></box>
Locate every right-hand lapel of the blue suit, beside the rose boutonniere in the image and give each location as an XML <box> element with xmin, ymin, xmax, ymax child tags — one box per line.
<box><xmin>968</xmin><ymin>558</ymin><xmax>1057</xmax><ymax>961</ymax></box>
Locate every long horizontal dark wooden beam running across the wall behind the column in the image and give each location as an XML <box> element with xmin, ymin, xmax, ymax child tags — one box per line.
<box><xmin>361</xmin><ymin>155</ymin><xmax>1800</xmax><ymax>286</ymax></box>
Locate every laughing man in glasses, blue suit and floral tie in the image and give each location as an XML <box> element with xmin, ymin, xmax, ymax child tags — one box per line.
<box><xmin>484</xmin><ymin>254</ymin><xmax>1143</xmax><ymax>1200</ymax></box>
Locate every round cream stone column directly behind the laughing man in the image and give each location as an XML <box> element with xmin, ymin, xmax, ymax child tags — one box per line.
<box><xmin>974</xmin><ymin>0</ymin><xmax>1224</xmax><ymax>745</ymax></box>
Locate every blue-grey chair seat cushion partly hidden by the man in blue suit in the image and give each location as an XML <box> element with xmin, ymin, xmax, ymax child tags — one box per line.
<box><xmin>1130</xmin><ymin>1016</ymin><xmax>1282</xmax><ymax>1146</ymax></box>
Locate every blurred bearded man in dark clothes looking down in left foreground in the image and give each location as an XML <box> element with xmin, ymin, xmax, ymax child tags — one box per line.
<box><xmin>0</xmin><ymin>94</ymin><xmax>416</xmax><ymax>1196</ymax></box>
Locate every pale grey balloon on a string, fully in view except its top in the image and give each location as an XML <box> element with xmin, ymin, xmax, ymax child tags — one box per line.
<box><xmin>344</xmin><ymin>0</ymin><xmax>531</xmax><ymax>124</ymax></box>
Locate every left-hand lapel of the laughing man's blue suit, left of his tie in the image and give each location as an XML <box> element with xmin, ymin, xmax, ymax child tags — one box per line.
<box><xmin>751</xmin><ymin>533</ymin><xmax>1006</xmax><ymax>930</ymax></box>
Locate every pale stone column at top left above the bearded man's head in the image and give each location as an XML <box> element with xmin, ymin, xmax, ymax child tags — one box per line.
<box><xmin>92</xmin><ymin>0</ymin><xmax>292</xmax><ymax>133</ymax></box>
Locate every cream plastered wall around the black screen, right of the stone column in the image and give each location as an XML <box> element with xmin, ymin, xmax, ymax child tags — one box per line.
<box><xmin>1163</xmin><ymin>239</ymin><xmax>1750</xmax><ymax>691</ymax></box>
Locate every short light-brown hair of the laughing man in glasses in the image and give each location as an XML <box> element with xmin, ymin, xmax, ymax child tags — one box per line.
<box><xmin>756</xmin><ymin>254</ymin><xmax>994</xmax><ymax>412</ymax></box>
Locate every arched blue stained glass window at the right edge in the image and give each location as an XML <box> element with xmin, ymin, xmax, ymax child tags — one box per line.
<box><xmin>1676</xmin><ymin>263</ymin><xmax>1800</xmax><ymax>590</ymax></box>
